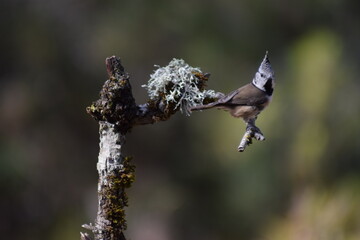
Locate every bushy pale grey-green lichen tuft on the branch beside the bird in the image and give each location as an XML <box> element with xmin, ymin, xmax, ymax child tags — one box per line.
<box><xmin>142</xmin><ymin>58</ymin><xmax>216</xmax><ymax>116</ymax></box>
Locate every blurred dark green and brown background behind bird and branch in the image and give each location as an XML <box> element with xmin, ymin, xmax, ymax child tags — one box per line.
<box><xmin>0</xmin><ymin>0</ymin><xmax>360</xmax><ymax>240</ymax></box>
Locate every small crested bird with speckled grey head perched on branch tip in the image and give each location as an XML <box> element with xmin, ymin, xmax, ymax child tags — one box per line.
<box><xmin>190</xmin><ymin>51</ymin><xmax>275</xmax><ymax>151</ymax></box>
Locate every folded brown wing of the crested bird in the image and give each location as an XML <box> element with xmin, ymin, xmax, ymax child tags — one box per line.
<box><xmin>218</xmin><ymin>83</ymin><xmax>268</xmax><ymax>106</ymax></box>
